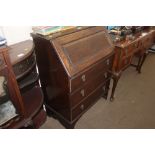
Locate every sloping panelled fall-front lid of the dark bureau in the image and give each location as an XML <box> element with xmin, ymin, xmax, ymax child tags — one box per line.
<box><xmin>51</xmin><ymin>27</ymin><xmax>114</xmax><ymax>77</ymax></box>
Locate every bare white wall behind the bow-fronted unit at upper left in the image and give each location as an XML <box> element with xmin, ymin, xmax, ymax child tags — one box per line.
<box><xmin>0</xmin><ymin>26</ymin><xmax>32</xmax><ymax>45</ymax></box>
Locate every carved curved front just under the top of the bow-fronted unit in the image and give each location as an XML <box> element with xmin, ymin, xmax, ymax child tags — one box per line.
<box><xmin>13</xmin><ymin>54</ymin><xmax>36</xmax><ymax>79</ymax></box>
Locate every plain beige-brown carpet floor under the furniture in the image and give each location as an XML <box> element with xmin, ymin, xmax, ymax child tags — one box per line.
<box><xmin>41</xmin><ymin>54</ymin><xmax>155</xmax><ymax>129</ymax></box>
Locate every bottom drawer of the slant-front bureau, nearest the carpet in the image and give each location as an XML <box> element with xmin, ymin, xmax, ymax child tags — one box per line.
<box><xmin>72</xmin><ymin>81</ymin><xmax>108</xmax><ymax>121</ymax></box>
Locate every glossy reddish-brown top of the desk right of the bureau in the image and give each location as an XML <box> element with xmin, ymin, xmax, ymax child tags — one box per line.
<box><xmin>115</xmin><ymin>28</ymin><xmax>155</xmax><ymax>48</ymax></box>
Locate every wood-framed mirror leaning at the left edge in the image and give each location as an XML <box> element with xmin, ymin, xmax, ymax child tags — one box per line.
<box><xmin>0</xmin><ymin>46</ymin><xmax>25</xmax><ymax>128</ymax></box>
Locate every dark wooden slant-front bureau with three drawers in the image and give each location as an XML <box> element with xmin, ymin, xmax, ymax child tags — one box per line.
<box><xmin>31</xmin><ymin>27</ymin><xmax>114</xmax><ymax>128</ymax></box>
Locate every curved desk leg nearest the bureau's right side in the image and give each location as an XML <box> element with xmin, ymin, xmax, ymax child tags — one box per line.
<box><xmin>110</xmin><ymin>73</ymin><xmax>121</xmax><ymax>101</ymax></box>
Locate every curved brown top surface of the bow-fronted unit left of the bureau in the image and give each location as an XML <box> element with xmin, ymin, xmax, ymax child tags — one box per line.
<box><xmin>9</xmin><ymin>40</ymin><xmax>34</xmax><ymax>65</ymax></box>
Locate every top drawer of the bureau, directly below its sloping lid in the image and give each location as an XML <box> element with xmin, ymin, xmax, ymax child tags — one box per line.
<box><xmin>70</xmin><ymin>55</ymin><xmax>113</xmax><ymax>92</ymax></box>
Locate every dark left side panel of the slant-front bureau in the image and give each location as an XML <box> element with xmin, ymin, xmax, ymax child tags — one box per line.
<box><xmin>33</xmin><ymin>37</ymin><xmax>71</xmax><ymax>121</ymax></box>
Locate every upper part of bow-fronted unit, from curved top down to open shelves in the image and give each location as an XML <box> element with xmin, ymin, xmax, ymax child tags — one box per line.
<box><xmin>9</xmin><ymin>40</ymin><xmax>39</xmax><ymax>92</ymax></box>
